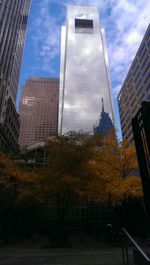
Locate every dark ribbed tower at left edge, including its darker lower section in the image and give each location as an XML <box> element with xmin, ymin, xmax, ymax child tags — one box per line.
<box><xmin>0</xmin><ymin>0</ymin><xmax>30</xmax><ymax>149</ymax></box>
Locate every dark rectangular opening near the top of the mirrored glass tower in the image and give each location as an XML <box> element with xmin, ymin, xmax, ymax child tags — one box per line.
<box><xmin>75</xmin><ymin>18</ymin><xmax>93</xmax><ymax>34</ymax></box>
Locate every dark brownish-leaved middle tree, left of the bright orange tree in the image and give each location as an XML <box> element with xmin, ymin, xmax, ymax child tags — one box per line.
<box><xmin>38</xmin><ymin>133</ymin><xmax>92</xmax><ymax>206</ymax></box>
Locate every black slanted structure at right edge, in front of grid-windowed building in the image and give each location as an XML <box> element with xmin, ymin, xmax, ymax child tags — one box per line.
<box><xmin>132</xmin><ymin>101</ymin><xmax>150</xmax><ymax>217</ymax></box>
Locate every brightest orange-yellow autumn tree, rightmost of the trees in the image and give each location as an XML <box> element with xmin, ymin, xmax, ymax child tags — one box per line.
<box><xmin>93</xmin><ymin>133</ymin><xmax>143</xmax><ymax>202</ymax></box>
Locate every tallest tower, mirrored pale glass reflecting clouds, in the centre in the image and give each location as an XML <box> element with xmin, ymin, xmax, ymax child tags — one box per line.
<box><xmin>59</xmin><ymin>6</ymin><xmax>114</xmax><ymax>133</ymax></box>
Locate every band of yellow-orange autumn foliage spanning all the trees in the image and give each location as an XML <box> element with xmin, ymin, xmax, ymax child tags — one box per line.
<box><xmin>0</xmin><ymin>132</ymin><xmax>143</xmax><ymax>206</ymax></box>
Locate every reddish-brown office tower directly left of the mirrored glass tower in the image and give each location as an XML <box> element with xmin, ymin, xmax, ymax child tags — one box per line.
<box><xmin>19</xmin><ymin>77</ymin><xmax>59</xmax><ymax>147</ymax></box>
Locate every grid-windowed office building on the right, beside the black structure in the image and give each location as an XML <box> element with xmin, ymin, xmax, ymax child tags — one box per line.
<box><xmin>118</xmin><ymin>24</ymin><xmax>150</xmax><ymax>142</ymax></box>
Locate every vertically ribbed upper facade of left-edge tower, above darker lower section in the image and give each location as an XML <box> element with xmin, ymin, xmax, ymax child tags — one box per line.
<box><xmin>0</xmin><ymin>0</ymin><xmax>30</xmax><ymax>109</ymax></box>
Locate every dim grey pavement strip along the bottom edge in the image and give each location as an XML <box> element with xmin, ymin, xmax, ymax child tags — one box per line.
<box><xmin>0</xmin><ymin>248</ymin><xmax>124</xmax><ymax>265</ymax></box>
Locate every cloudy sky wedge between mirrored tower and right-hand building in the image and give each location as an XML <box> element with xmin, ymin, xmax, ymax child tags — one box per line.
<box><xmin>101</xmin><ymin>0</ymin><xmax>150</xmax><ymax>99</ymax></box>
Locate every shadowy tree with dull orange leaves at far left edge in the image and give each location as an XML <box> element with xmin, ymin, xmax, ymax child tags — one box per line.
<box><xmin>0</xmin><ymin>153</ymin><xmax>39</xmax><ymax>234</ymax></box>
